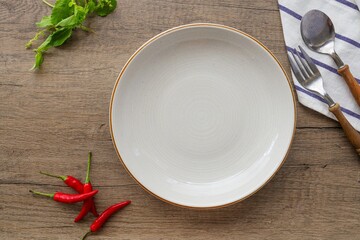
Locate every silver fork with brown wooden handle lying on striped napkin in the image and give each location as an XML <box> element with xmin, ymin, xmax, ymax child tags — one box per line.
<box><xmin>288</xmin><ymin>46</ymin><xmax>360</xmax><ymax>156</ymax></box>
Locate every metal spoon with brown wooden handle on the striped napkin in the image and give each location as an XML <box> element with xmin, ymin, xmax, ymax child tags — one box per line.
<box><xmin>300</xmin><ymin>10</ymin><xmax>360</xmax><ymax>106</ymax></box>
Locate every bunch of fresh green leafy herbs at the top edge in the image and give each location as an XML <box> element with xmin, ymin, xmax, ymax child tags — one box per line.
<box><xmin>26</xmin><ymin>0</ymin><xmax>117</xmax><ymax>69</ymax></box>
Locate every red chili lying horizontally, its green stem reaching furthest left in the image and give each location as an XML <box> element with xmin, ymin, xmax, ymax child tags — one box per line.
<box><xmin>30</xmin><ymin>190</ymin><xmax>99</xmax><ymax>203</ymax></box>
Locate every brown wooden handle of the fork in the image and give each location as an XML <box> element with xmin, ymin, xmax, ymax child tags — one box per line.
<box><xmin>329</xmin><ymin>103</ymin><xmax>360</xmax><ymax>156</ymax></box>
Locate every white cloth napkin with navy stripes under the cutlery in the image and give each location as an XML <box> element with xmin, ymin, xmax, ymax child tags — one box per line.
<box><xmin>278</xmin><ymin>0</ymin><xmax>360</xmax><ymax>131</ymax></box>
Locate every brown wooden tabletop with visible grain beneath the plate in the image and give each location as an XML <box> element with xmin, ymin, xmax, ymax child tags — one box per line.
<box><xmin>0</xmin><ymin>0</ymin><xmax>360</xmax><ymax>240</ymax></box>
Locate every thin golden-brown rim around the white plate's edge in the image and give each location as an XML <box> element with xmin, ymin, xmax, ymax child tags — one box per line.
<box><xmin>109</xmin><ymin>23</ymin><xmax>297</xmax><ymax>210</ymax></box>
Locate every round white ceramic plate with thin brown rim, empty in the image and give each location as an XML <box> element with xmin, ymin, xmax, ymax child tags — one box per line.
<box><xmin>110</xmin><ymin>24</ymin><xmax>295</xmax><ymax>208</ymax></box>
